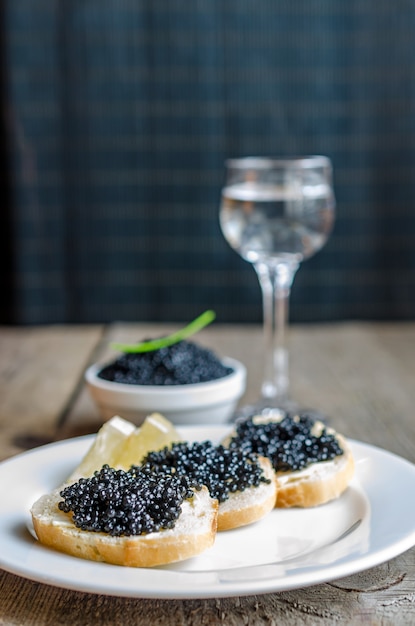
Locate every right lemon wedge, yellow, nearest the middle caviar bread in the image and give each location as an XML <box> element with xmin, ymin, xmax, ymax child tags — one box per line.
<box><xmin>115</xmin><ymin>413</ymin><xmax>182</xmax><ymax>469</ymax></box>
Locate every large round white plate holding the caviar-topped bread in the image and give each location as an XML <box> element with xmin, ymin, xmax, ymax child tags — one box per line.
<box><xmin>0</xmin><ymin>426</ymin><xmax>415</xmax><ymax>598</ymax></box>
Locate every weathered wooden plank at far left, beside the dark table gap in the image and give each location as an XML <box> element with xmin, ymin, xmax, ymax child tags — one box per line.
<box><xmin>0</xmin><ymin>326</ymin><xmax>102</xmax><ymax>459</ymax></box>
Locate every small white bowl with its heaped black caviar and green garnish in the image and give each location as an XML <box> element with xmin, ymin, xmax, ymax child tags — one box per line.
<box><xmin>85</xmin><ymin>312</ymin><xmax>246</xmax><ymax>424</ymax></box>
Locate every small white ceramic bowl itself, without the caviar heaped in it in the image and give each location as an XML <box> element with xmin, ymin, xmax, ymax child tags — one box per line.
<box><xmin>85</xmin><ymin>358</ymin><xmax>246</xmax><ymax>425</ymax></box>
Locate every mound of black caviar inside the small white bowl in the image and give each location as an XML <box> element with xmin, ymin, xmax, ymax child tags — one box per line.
<box><xmin>98</xmin><ymin>340</ymin><xmax>233</xmax><ymax>385</ymax></box>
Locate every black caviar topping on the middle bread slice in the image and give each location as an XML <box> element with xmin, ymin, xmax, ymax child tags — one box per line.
<box><xmin>143</xmin><ymin>441</ymin><xmax>270</xmax><ymax>502</ymax></box>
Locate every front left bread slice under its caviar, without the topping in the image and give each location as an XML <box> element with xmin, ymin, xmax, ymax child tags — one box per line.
<box><xmin>31</xmin><ymin>487</ymin><xmax>218</xmax><ymax>567</ymax></box>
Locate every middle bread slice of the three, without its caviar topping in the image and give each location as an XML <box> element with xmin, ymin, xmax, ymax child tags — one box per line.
<box><xmin>218</xmin><ymin>457</ymin><xmax>277</xmax><ymax>531</ymax></box>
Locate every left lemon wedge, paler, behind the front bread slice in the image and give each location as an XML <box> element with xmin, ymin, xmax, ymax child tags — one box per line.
<box><xmin>67</xmin><ymin>415</ymin><xmax>136</xmax><ymax>482</ymax></box>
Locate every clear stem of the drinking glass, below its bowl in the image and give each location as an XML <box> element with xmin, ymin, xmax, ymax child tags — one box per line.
<box><xmin>254</xmin><ymin>259</ymin><xmax>299</xmax><ymax>407</ymax></box>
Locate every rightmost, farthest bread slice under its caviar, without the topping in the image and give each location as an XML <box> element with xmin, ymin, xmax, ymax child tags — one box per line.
<box><xmin>223</xmin><ymin>414</ymin><xmax>354</xmax><ymax>508</ymax></box>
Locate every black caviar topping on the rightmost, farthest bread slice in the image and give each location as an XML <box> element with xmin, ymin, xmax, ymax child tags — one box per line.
<box><xmin>229</xmin><ymin>413</ymin><xmax>344</xmax><ymax>472</ymax></box>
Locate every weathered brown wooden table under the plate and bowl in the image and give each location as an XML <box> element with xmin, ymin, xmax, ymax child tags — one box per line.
<box><xmin>0</xmin><ymin>323</ymin><xmax>415</xmax><ymax>626</ymax></box>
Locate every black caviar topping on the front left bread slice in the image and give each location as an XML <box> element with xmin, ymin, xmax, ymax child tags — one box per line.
<box><xmin>58</xmin><ymin>465</ymin><xmax>194</xmax><ymax>536</ymax></box>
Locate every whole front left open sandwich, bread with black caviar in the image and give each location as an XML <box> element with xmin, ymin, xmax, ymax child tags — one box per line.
<box><xmin>31</xmin><ymin>466</ymin><xmax>218</xmax><ymax>567</ymax></box>
